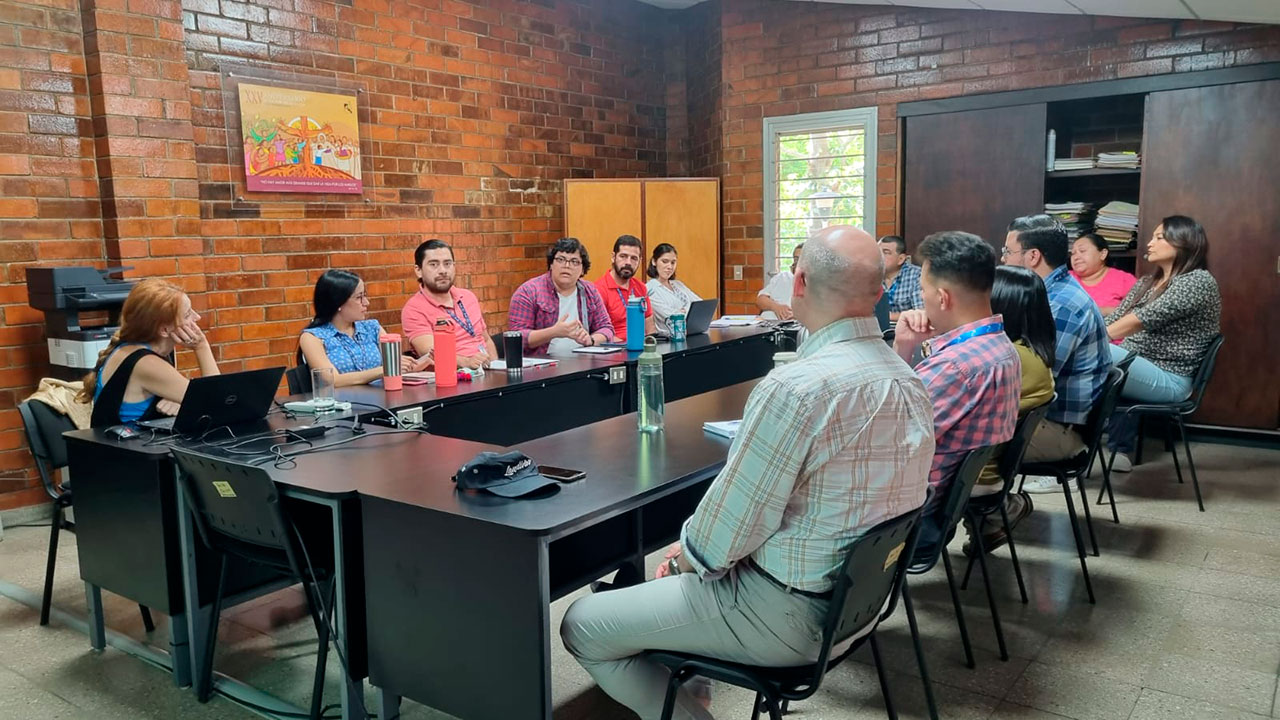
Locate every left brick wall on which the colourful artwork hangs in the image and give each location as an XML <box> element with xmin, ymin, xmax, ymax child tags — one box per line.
<box><xmin>0</xmin><ymin>0</ymin><xmax>687</xmax><ymax>509</ymax></box>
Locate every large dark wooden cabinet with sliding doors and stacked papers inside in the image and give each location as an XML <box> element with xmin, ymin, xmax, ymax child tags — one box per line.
<box><xmin>897</xmin><ymin>63</ymin><xmax>1280</xmax><ymax>430</ymax></box>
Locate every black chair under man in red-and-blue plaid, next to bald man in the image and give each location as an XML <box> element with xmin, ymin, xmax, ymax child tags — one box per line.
<box><xmin>902</xmin><ymin>447</ymin><xmax>993</xmax><ymax>720</ymax></box>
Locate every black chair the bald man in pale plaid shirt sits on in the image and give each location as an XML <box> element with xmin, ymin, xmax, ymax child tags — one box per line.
<box><xmin>646</xmin><ymin>497</ymin><xmax>920</xmax><ymax>720</ymax></box>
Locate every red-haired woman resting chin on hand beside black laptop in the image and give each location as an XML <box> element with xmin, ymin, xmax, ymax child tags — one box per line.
<box><xmin>77</xmin><ymin>278</ymin><xmax>218</xmax><ymax>428</ymax></box>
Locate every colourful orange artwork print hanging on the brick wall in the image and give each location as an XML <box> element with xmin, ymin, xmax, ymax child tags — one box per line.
<box><xmin>239</xmin><ymin>82</ymin><xmax>364</xmax><ymax>193</ymax></box>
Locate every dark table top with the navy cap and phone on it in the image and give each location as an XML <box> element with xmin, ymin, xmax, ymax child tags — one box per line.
<box><xmin>271</xmin><ymin>380</ymin><xmax>758</xmax><ymax>534</ymax></box>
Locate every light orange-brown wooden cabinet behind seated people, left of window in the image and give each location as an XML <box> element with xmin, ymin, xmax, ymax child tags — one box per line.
<box><xmin>564</xmin><ymin>178</ymin><xmax>721</xmax><ymax>299</ymax></box>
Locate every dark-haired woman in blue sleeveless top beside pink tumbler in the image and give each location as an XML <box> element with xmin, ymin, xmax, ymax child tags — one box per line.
<box><xmin>298</xmin><ymin>270</ymin><xmax>430</xmax><ymax>387</ymax></box>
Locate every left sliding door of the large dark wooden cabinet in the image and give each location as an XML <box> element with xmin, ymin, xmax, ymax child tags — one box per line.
<box><xmin>902</xmin><ymin>102</ymin><xmax>1044</xmax><ymax>251</ymax></box>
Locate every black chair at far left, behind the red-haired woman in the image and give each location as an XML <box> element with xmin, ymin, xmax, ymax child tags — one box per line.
<box><xmin>18</xmin><ymin>400</ymin><xmax>156</xmax><ymax>633</ymax></box>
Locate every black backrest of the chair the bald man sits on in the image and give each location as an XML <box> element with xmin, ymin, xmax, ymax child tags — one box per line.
<box><xmin>813</xmin><ymin>488</ymin><xmax>933</xmax><ymax>676</ymax></box>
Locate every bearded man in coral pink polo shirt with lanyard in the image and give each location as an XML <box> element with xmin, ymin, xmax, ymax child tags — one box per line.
<box><xmin>401</xmin><ymin>240</ymin><xmax>498</xmax><ymax>369</ymax></box>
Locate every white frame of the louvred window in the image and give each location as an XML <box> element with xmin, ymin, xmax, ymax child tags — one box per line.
<box><xmin>762</xmin><ymin>105</ymin><xmax>879</xmax><ymax>274</ymax></box>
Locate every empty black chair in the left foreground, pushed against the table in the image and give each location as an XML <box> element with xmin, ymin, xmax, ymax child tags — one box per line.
<box><xmin>173</xmin><ymin>448</ymin><xmax>334</xmax><ymax>720</ymax></box>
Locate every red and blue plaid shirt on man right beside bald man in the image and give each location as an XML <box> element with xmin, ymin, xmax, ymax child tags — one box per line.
<box><xmin>915</xmin><ymin>315</ymin><xmax>1023</xmax><ymax>502</ymax></box>
